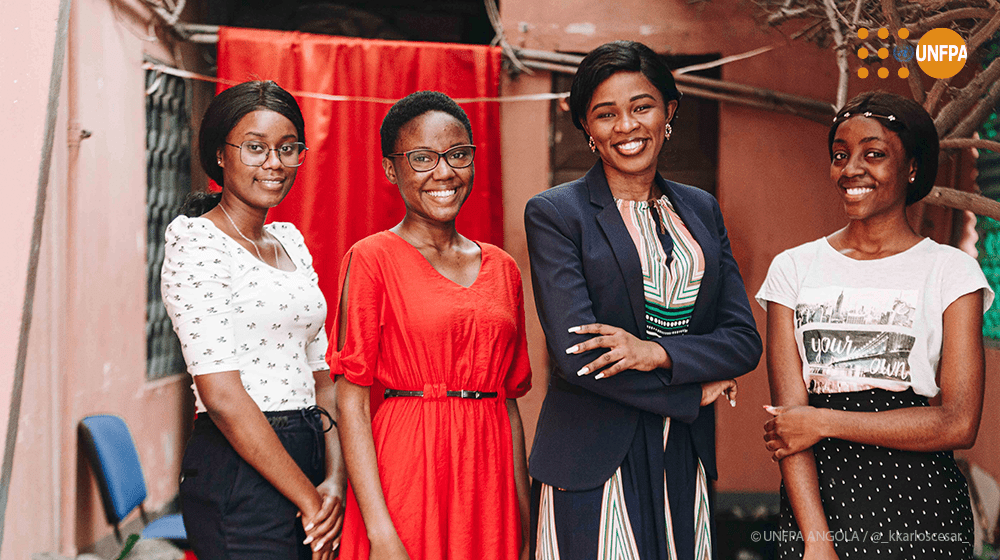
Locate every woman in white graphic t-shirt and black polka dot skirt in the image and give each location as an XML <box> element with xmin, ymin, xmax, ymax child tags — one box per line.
<box><xmin>757</xmin><ymin>92</ymin><xmax>993</xmax><ymax>559</ymax></box>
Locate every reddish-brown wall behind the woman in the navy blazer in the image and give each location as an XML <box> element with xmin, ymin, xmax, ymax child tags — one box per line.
<box><xmin>501</xmin><ymin>0</ymin><xmax>1000</xmax><ymax>492</ymax></box>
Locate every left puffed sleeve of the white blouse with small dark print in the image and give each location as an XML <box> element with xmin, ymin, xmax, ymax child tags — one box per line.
<box><xmin>160</xmin><ymin>216</ymin><xmax>239</xmax><ymax>375</ymax></box>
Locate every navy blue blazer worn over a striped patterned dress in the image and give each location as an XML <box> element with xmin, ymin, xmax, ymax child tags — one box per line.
<box><xmin>524</xmin><ymin>161</ymin><xmax>761</xmax><ymax>490</ymax></box>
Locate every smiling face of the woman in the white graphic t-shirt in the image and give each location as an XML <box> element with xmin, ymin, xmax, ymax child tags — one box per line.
<box><xmin>830</xmin><ymin>116</ymin><xmax>916</xmax><ymax>220</ymax></box>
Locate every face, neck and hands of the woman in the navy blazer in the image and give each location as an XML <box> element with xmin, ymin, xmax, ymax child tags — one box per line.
<box><xmin>566</xmin><ymin>72</ymin><xmax>736</xmax><ymax>406</ymax></box>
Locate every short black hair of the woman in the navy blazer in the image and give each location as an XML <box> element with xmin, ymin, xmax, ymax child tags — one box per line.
<box><xmin>569</xmin><ymin>41</ymin><xmax>681</xmax><ymax>130</ymax></box>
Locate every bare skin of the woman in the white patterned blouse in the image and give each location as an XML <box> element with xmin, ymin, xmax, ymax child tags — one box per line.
<box><xmin>194</xmin><ymin>110</ymin><xmax>347</xmax><ymax>560</ymax></box>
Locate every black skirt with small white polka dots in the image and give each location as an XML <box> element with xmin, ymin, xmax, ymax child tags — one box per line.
<box><xmin>776</xmin><ymin>389</ymin><xmax>973</xmax><ymax>560</ymax></box>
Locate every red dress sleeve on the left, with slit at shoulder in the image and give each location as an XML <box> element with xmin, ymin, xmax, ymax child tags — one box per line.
<box><xmin>327</xmin><ymin>245</ymin><xmax>385</xmax><ymax>386</ymax></box>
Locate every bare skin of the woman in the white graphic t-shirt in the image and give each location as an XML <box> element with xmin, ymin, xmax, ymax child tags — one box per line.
<box><xmin>764</xmin><ymin>116</ymin><xmax>985</xmax><ymax>559</ymax></box>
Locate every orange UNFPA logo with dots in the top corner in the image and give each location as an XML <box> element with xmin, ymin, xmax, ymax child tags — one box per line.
<box><xmin>858</xmin><ymin>27</ymin><xmax>969</xmax><ymax>79</ymax></box>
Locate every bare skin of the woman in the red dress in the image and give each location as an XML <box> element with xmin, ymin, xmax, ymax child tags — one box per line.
<box><xmin>337</xmin><ymin>111</ymin><xmax>530</xmax><ymax>560</ymax></box>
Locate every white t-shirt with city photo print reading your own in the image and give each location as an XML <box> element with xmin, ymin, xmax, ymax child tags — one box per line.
<box><xmin>756</xmin><ymin>238</ymin><xmax>993</xmax><ymax>397</ymax></box>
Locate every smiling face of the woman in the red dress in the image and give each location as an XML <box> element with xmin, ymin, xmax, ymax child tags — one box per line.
<box><xmin>382</xmin><ymin>111</ymin><xmax>476</xmax><ymax>228</ymax></box>
